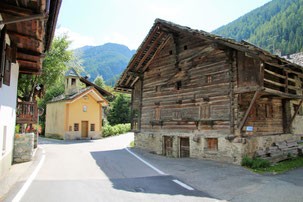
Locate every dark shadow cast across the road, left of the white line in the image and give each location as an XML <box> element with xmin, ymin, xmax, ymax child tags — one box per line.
<box><xmin>91</xmin><ymin>149</ymin><xmax>213</xmax><ymax>198</ymax></box>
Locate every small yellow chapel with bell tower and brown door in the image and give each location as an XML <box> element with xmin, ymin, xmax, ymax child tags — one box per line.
<box><xmin>45</xmin><ymin>68</ymin><xmax>111</xmax><ymax>139</ymax></box>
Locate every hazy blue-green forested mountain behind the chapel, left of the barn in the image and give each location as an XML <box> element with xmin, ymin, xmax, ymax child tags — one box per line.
<box><xmin>75</xmin><ymin>43</ymin><xmax>136</xmax><ymax>85</ymax></box>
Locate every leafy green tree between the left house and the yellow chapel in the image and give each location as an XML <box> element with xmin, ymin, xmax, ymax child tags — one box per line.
<box><xmin>18</xmin><ymin>35</ymin><xmax>74</xmax><ymax>101</ymax></box>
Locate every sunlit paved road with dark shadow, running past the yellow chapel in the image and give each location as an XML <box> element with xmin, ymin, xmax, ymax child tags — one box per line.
<box><xmin>4</xmin><ymin>134</ymin><xmax>217</xmax><ymax>202</ymax></box>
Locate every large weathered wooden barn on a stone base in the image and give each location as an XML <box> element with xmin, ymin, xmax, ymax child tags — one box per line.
<box><xmin>115</xmin><ymin>19</ymin><xmax>303</xmax><ymax>163</ymax></box>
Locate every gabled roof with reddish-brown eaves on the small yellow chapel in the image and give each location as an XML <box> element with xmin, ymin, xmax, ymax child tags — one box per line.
<box><xmin>48</xmin><ymin>86</ymin><xmax>108</xmax><ymax>105</ymax></box>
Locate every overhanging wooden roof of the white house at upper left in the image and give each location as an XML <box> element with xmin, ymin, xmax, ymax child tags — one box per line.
<box><xmin>0</xmin><ymin>0</ymin><xmax>62</xmax><ymax>74</ymax></box>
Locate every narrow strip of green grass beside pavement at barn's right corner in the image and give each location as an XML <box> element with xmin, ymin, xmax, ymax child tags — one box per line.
<box><xmin>245</xmin><ymin>156</ymin><xmax>303</xmax><ymax>174</ymax></box>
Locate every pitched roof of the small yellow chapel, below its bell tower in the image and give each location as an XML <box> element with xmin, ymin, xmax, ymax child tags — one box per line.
<box><xmin>47</xmin><ymin>86</ymin><xmax>108</xmax><ymax>104</ymax></box>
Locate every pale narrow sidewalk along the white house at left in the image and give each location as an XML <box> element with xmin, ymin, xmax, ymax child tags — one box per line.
<box><xmin>0</xmin><ymin>147</ymin><xmax>42</xmax><ymax>201</ymax></box>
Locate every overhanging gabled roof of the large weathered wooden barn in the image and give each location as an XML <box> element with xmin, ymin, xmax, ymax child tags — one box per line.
<box><xmin>115</xmin><ymin>19</ymin><xmax>303</xmax><ymax>92</ymax></box>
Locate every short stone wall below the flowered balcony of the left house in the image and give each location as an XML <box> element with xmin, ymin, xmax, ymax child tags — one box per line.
<box><xmin>13</xmin><ymin>133</ymin><xmax>34</xmax><ymax>163</ymax></box>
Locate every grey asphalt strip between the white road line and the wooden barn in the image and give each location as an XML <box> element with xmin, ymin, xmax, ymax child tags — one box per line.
<box><xmin>130</xmin><ymin>148</ymin><xmax>303</xmax><ymax>202</ymax></box>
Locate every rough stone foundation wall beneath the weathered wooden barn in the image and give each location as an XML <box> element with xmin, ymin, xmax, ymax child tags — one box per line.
<box><xmin>135</xmin><ymin>132</ymin><xmax>301</xmax><ymax>165</ymax></box>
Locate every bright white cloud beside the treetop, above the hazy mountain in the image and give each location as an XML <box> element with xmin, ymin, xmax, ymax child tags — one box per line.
<box><xmin>55</xmin><ymin>27</ymin><xmax>97</xmax><ymax>49</ymax></box>
